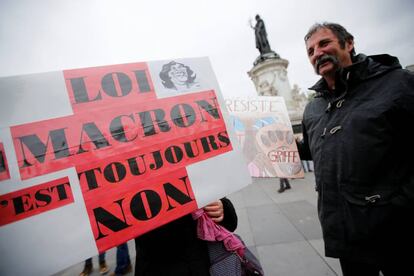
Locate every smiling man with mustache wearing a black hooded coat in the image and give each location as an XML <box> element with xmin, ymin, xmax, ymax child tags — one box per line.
<box><xmin>298</xmin><ymin>23</ymin><xmax>414</xmax><ymax>276</ymax></box>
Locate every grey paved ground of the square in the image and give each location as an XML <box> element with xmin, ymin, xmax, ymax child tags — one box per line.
<box><xmin>56</xmin><ymin>173</ymin><xmax>342</xmax><ymax>276</ymax></box>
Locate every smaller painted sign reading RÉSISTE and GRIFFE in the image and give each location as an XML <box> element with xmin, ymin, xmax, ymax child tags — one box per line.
<box><xmin>225</xmin><ymin>96</ymin><xmax>304</xmax><ymax>178</ymax></box>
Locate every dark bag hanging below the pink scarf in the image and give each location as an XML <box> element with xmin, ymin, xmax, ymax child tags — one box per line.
<box><xmin>207</xmin><ymin>235</ymin><xmax>264</xmax><ymax>276</ymax></box>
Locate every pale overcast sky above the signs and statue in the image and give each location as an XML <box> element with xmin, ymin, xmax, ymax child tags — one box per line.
<box><xmin>0</xmin><ymin>0</ymin><xmax>414</xmax><ymax>97</ymax></box>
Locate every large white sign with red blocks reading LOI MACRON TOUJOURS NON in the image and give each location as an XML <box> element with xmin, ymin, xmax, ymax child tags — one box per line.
<box><xmin>0</xmin><ymin>58</ymin><xmax>251</xmax><ymax>275</ymax></box>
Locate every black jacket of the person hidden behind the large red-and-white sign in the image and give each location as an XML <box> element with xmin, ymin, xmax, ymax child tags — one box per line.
<box><xmin>135</xmin><ymin>198</ymin><xmax>237</xmax><ymax>276</ymax></box>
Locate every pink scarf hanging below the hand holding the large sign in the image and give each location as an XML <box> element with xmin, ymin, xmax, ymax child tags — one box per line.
<box><xmin>191</xmin><ymin>209</ymin><xmax>245</xmax><ymax>257</ymax></box>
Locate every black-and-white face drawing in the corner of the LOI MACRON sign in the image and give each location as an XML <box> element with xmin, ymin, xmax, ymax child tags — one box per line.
<box><xmin>159</xmin><ymin>61</ymin><xmax>198</xmax><ymax>90</ymax></box>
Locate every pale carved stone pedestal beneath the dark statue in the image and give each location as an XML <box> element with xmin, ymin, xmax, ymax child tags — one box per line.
<box><xmin>248</xmin><ymin>57</ymin><xmax>303</xmax><ymax>126</ymax></box>
